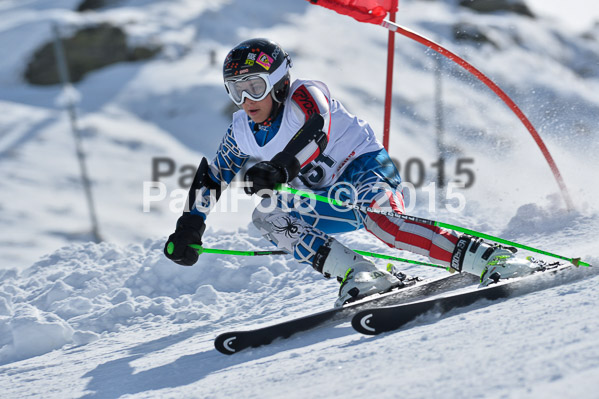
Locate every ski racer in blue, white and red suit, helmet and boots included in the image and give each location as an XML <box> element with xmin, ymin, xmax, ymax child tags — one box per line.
<box><xmin>164</xmin><ymin>39</ymin><xmax>530</xmax><ymax>306</ymax></box>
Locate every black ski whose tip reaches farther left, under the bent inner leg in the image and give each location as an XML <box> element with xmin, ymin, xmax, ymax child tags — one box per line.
<box><xmin>214</xmin><ymin>273</ymin><xmax>478</xmax><ymax>355</ymax></box>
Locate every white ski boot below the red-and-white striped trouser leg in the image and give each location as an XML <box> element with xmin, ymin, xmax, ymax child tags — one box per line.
<box><xmin>451</xmin><ymin>235</ymin><xmax>538</xmax><ymax>287</ymax></box>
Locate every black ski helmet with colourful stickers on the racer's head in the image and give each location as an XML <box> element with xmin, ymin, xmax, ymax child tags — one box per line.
<box><xmin>223</xmin><ymin>38</ymin><xmax>292</xmax><ymax>105</ymax></box>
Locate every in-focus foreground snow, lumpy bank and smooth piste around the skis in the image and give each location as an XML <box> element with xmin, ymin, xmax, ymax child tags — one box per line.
<box><xmin>0</xmin><ymin>229</ymin><xmax>599</xmax><ymax>398</ymax></box>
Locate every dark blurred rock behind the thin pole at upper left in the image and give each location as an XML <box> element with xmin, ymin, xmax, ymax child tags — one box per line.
<box><xmin>24</xmin><ymin>24</ymin><xmax>160</xmax><ymax>85</ymax></box>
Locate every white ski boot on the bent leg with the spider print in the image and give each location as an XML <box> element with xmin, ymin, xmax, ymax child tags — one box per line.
<box><xmin>313</xmin><ymin>239</ymin><xmax>402</xmax><ymax>307</ymax></box>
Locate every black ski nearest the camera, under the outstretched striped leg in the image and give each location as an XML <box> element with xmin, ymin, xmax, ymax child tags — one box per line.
<box><xmin>352</xmin><ymin>262</ymin><xmax>583</xmax><ymax>335</ymax></box>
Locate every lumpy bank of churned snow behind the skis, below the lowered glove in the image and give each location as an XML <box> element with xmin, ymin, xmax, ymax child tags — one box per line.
<box><xmin>0</xmin><ymin>231</ymin><xmax>328</xmax><ymax>364</ymax></box>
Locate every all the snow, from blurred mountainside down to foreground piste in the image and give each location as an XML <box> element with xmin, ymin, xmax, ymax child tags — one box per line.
<box><xmin>0</xmin><ymin>0</ymin><xmax>599</xmax><ymax>398</ymax></box>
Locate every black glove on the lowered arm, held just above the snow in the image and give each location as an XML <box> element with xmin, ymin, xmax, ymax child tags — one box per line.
<box><xmin>164</xmin><ymin>213</ymin><xmax>206</xmax><ymax>266</ymax></box>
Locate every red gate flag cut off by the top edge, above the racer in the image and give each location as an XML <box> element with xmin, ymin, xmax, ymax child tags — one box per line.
<box><xmin>307</xmin><ymin>0</ymin><xmax>397</xmax><ymax>25</ymax></box>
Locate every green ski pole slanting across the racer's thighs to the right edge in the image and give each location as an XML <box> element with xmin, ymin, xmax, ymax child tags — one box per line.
<box><xmin>276</xmin><ymin>185</ymin><xmax>591</xmax><ymax>267</ymax></box>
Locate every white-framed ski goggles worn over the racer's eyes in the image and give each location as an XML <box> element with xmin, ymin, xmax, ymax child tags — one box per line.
<box><xmin>225</xmin><ymin>62</ymin><xmax>287</xmax><ymax>106</ymax></box>
